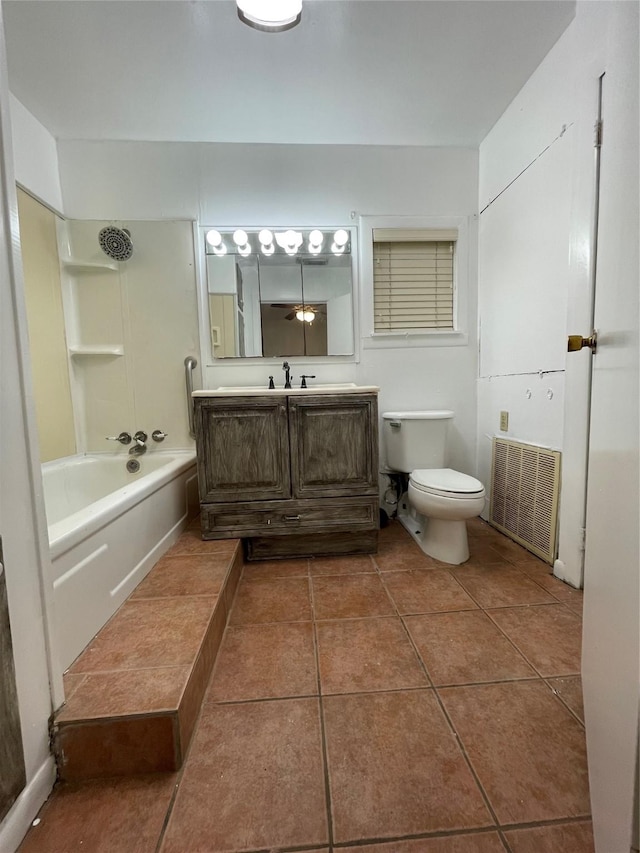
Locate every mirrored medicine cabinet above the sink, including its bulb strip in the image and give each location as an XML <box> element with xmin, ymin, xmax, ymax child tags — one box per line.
<box><xmin>204</xmin><ymin>228</ymin><xmax>354</xmax><ymax>358</ymax></box>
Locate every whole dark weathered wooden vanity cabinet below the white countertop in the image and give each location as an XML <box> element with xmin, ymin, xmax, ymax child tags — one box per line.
<box><xmin>195</xmin><ymin>393</ymin><xmax>379</xmax><ymax>559</ymax></box>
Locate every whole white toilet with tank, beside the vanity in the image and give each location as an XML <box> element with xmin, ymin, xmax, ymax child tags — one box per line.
<box><xmin>382</xmin><ymin>410</ymin><xmax>485</xmax><ymax>566</ymax></box>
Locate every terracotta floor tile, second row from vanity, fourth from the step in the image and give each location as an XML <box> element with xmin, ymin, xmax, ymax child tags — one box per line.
<box><xmin>451</xmin><ymin>566</ymin><xmax>554</xmax><ymax>607</ymax></box>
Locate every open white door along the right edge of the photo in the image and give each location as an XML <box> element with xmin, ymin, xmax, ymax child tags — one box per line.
<box><xmin>582</xmin><ymin>3</ymin><xmax>640</xmax><ymax>853</ymax></box>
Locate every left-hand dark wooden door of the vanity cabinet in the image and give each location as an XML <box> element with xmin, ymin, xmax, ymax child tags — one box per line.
<box><xmin>195</xmin><ymin>397</ymin><xmax>291</xmax><ymax>503</ymax></box>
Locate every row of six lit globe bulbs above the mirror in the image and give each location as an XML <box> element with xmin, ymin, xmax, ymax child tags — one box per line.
<box><xmin>205</xmin><ymin>228</ymin><xmax>351</xmax><ymax>257</ymax></box>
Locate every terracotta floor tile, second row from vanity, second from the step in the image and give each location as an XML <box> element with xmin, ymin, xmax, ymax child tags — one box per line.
<box><xmin>311</xmin><ymin>574</ymin><xmax>395</xmax><ymax>619</ymax></box>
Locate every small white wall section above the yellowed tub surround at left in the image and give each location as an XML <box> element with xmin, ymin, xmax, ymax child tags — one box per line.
<box><xmin>10</xmin><ymin>95</ymin><xmax>62</xmax><ymax>212</ymax></box>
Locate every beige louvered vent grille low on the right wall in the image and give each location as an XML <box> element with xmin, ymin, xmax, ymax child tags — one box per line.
<box><xmin>491</xmin><ymin>438</ymin><xmax>560</xmax><ymax>564</ymax></box>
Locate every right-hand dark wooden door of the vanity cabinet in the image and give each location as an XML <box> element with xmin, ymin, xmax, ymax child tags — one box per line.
<box><xmin>289</xmin><ymin>394</ymin><xmax>378</xmax><ymax>498</ymax></box>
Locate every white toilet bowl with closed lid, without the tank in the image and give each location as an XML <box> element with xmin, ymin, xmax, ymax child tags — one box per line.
<box><xmin>399</xmin><ymin>468</ymin><xmax>485</xmax><ymax>565</ymax></box>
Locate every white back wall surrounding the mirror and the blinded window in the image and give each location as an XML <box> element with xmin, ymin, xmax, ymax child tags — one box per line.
<box><xmin>58</xmin><ymin>140</ymin><xmax>477</xmax><ymax>473</ymax></box>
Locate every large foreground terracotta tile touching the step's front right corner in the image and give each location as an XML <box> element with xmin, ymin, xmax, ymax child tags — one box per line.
<box><xmin>161</xmin><ymin>699</ymin><xmax>328</xmax><ymax>853</ymax></box>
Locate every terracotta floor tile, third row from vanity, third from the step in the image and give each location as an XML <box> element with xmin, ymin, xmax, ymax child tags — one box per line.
<box><xmin>405</xmin><ymin>610</ymin><xmax>536</xmax><ymax>685</ymax></box>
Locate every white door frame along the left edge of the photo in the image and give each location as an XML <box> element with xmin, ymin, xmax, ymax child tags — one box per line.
<box><xmin>0</xmin><ymin>9</ymin><xmax>61</xmax><ymax>851</ymax></box>
